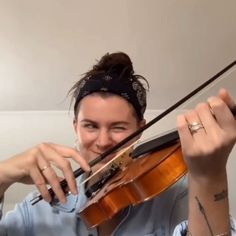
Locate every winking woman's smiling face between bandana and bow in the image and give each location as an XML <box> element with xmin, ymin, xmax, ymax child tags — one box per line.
<box><xmin>74</xmin><ymin>94</ymin><xmax>144</xmax><ymax>169</ymax></box>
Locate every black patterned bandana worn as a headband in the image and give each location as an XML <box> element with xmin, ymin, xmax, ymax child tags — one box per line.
<box><xmin>74</xmin><ymin>73</ymin><xmax>146</xmax><ymax>119</ymax></box>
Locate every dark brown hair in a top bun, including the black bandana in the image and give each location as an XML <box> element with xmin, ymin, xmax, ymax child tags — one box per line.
<box><xmin>69</xmin><ymin>52</ymin><xmax>149</xmax><ymax>119</ymax></box>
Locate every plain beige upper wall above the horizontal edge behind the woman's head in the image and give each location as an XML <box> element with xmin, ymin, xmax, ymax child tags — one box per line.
<box><xmin>0</xmin><ymin>0</ymin><xmax>236</xmax><ymax>111</ymax></box>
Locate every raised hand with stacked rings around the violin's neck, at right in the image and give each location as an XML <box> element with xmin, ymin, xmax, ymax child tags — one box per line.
<box><xmin>177</xmin><ymin>89</ymin><xmax>236</xmax><ymax>178</ymax></box>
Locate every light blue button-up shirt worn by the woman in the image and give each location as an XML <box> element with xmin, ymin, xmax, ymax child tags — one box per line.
<box><xmin>0</xmin><ymin>176</ymin><xmax>235</xmax><ymax>236</ymax></box>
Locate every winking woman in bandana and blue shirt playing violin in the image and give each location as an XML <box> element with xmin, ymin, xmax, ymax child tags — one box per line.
<box><xmin>0</xmin><ymin>53</ymin><xmax>236</xmax><ymax>236</ymax></box>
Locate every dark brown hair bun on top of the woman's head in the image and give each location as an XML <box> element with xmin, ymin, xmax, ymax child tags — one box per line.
<box><xmin>93</xmin><ymin>52</ymin><xmax>134</xmax><ymax>76</ymax></box>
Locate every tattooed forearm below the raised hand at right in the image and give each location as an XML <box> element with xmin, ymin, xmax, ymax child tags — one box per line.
<box><xmin>189</xmin><ymin>173</ymin><xmax>230</xmax><ymax>236</ymax></box>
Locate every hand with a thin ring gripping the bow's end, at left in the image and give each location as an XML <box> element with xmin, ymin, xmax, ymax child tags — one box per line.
<box><xmin>0</xmin><ymin>143</ymin><xmax>90</xmax><ymax>203</ymax></box>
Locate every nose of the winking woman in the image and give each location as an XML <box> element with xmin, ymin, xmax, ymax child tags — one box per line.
<box><xmin>96</xmin><ymin>129</ymin><xmax>113</xmax><ymax>151</ymax></box>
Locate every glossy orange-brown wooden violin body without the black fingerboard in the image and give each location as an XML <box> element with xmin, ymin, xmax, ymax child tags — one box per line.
<box><xmin>79</xmin><ymin>142</ymin><xmax>187</xmax><ymax>228</ymax></box>
